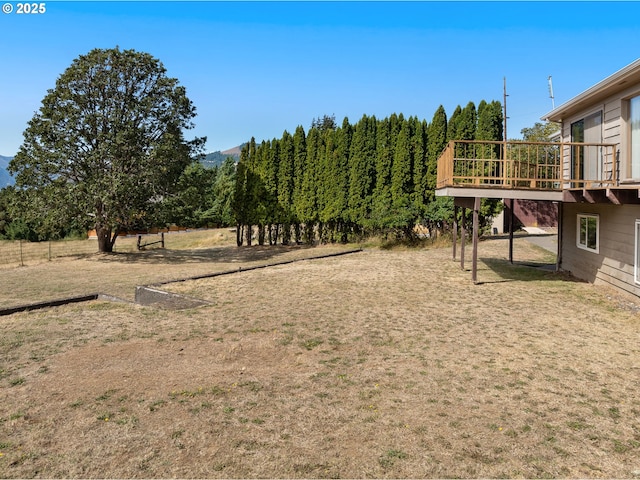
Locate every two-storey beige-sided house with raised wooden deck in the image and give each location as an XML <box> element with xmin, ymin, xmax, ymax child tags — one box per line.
<box><xmin>436</xmin><ymin>59</ymin><xmax>640</xmax><ymax>296</ymax></box>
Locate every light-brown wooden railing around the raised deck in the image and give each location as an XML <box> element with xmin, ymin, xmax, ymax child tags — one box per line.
<box><xmin>437</xmin><ymin>140</ymin><xmax>620</xmax><ymax>191</ymax></box>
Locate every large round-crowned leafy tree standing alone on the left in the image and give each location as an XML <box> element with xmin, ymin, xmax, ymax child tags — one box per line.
<box><xmin>9</xmin><ymin>48</ymin><xmax>204</xmax><ymax>252</ymax></box>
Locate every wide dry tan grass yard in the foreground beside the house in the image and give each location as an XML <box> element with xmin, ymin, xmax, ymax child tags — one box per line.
<box><xmin>0</xmin><ymin>235</ymin><xmax>640</xmax><ymax>478</ymax></box>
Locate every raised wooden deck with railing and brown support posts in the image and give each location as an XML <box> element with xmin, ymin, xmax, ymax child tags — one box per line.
<box><xmin>436</xmin><ymin>140</ymin><xmax>620</xmax><ymax>283</ymax></box>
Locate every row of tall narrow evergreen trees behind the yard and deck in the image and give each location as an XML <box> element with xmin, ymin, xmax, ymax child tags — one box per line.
<box><xmin>232</xmin><ymin>100</ymin><xmax>503</xmax><ymax>245</ymax></box>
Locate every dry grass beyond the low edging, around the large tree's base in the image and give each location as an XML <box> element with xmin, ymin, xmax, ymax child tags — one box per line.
<box><xmin>0</xmin><ymin>229</ymin><xmax>353</xmax><ymax>308</ymax></box>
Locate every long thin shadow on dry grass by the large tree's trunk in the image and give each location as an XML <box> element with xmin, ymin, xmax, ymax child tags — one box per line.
<box><xmin>84</xmin><ymin>245</ymin><xmax>318</xmax><ymax>264</ymax></box>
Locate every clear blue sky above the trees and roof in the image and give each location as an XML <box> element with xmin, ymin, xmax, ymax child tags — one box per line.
<box><xmin>0</xmin><ymin>0</ymin><xmax>640</xmax><ymax>156</ymax></box>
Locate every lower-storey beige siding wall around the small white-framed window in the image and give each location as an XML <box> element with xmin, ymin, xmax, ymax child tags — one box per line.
<box><xmin>562</xmin><ymin>203</ymin><xmax>640</xmax><ymax>296</ymax></box>
